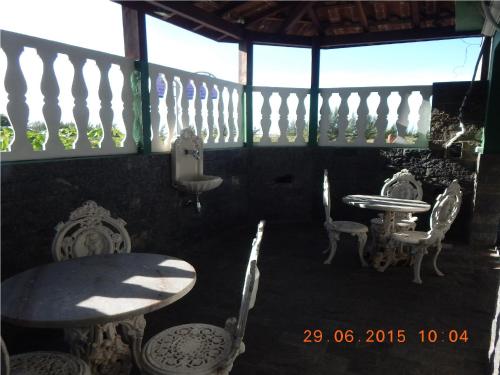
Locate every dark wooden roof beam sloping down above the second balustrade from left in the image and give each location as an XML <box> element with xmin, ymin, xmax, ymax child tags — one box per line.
<box><xmin>148</xmin><ymin>1</ymin><xmax>243</xmax><ymax>40</ymax></box>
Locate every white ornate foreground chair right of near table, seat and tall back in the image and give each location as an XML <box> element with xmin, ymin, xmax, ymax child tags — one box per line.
<box><xmin>141</xmin><ymin>221</ymin><xmax>264</xmax><ymax>375</ymax></box>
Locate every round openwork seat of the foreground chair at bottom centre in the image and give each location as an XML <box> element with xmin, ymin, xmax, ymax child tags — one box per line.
<box><xmin>142</xmin><ymin>323</ymin><xmax>233</xmax><ymax>375</ymax></box>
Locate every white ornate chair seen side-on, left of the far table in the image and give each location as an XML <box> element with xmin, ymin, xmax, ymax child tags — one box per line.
<box><xmin>323</xmin><ymin>169</ymin><xmax>368</xmax><ymax>267</ymax></box>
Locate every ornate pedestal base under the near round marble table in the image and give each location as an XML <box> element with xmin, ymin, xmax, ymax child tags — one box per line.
<box><xmin>65</xmin><ymin>315</ymin><xmax>146</xmax><ymax>375</ymax></box>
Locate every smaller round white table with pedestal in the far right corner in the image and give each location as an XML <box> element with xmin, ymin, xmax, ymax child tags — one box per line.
<box><xmin>342</xmin><ymin>195</ymin><xmax>431</xmax><ymax>272</ymax></box>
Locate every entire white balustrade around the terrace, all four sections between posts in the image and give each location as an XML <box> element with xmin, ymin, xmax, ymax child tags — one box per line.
<box><xmin>0</xmin><ymin>30</ymin><xmax>432</xmax><ymax>160</ymax></box>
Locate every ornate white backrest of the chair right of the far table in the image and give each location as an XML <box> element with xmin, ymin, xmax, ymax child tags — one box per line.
<box><xmin>430</xmin><ymin>180</ymin><xmax>462</xmax><ymax>239</ymax></box>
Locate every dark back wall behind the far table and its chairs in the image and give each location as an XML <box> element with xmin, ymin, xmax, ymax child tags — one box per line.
<box><xmin>248</xmin><ymin>147</ymin><xmax>474</xmax><ymax>241</ymax></box>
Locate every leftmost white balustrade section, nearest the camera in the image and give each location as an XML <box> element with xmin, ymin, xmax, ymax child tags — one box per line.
<box><xmin>0</xmin><ymin>30</ymin><xmax>137</xmax><ymax>161</ymax></box>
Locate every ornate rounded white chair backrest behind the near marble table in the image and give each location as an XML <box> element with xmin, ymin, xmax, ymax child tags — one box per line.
<box><xmin>52</xmin><ymin>201</ymin><xmax>130</xmax><ymax>261</ymax></box>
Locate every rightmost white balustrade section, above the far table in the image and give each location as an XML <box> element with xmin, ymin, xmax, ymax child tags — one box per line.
<box><xmin>318</xmin><ymin>86</ymin><xmax>432</xmax><ymax>148</ymax></box>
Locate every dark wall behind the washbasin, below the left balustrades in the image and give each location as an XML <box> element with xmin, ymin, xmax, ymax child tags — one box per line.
<box><xmin>1</xmin><ymin>149</ymin><xmax>248</xmax><ymax>279</ymax></box>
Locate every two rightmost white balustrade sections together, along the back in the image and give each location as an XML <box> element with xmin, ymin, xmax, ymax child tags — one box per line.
<box><xmin>253</xmin><ymin>86</ymin><xmax>432</xmax><ymax>148</ymax></box>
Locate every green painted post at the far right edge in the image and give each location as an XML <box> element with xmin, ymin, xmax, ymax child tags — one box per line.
<box><xmin>483</xmin><ymin>31</ymin><xmax>500</xmax><ymax>154</ymax></box>
